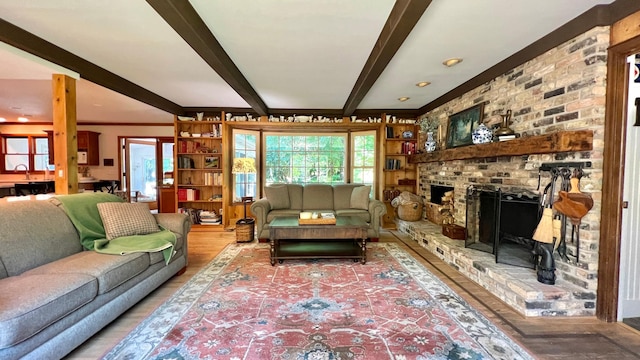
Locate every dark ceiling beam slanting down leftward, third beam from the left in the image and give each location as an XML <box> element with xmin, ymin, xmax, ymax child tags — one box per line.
<box><xmin>342</xmin><ymin>0</ymin><xmax>431</xmax><ymax>116</ymax></box>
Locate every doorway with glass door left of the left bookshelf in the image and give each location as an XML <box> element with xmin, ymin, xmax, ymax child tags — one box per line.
<box><xmin>120</xmin><ymin>137</ymin><xmax>175</xmax><ymax>212</ymax></box>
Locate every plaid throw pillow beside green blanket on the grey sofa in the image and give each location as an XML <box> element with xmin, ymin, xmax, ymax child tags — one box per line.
<box><xmin>97</xmin><ymin>202</ymin><xmax>160</xmax><ymax>240</ymax></box>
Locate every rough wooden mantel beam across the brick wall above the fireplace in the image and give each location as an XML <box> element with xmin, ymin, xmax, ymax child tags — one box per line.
<box><xmin>409</xmin><ymin>130</ymin><xmax>593</xmax><ymax>164</ymax></box>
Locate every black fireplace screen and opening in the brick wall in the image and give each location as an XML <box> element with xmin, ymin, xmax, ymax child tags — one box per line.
<box><xmin>465</xmin><ymin>187</ymin><xmax>540</xmax><ymax>268</ymax></box>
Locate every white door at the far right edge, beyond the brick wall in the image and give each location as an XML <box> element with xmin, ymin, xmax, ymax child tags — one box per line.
<box><xmin>616</xmin><ymin>52</ymin><xmax>640</xmax><ymax>321</ymax></box>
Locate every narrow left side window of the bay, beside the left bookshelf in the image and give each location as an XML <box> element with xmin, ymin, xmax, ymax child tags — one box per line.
<box><xmin>233</xmin><ymin>129</ymin><xmax>260</xmax><ymax>202</ymax></box>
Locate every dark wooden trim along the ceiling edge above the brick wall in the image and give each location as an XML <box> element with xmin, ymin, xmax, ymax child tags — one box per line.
<box><xmin>417</xmin><ymin>0</ymin><xmax>640</xmax><ymax>114</ymax></box>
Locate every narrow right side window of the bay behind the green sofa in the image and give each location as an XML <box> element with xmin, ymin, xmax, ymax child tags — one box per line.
<box><xmin>351</xmin><ymin>131</ymin><xmax>376</xmax><ymax>191</ymax></box>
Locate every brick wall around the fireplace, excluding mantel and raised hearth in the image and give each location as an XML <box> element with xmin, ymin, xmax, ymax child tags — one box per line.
<box><xmin>418</xmin><ymin>27</ymin><xmax>609</xmax><ymax>292</ymax></box>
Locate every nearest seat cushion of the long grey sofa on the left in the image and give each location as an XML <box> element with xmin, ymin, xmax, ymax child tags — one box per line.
<box><xmin>0</xmin><ymin>274</ymin><xmax>98</xmax><ymax>349</ymax></box>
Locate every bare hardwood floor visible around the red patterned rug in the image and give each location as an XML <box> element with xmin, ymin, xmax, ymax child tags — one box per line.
<box><xmin>67</xmin><ymin>228</ymin><xmax>640</xmax><ymax>360</ymax></box>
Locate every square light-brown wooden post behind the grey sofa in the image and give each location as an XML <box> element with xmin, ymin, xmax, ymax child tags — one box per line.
<box><xmin>52</xmin><ymin>74</ymin><xmax>78</xmax><ymax>194</ymax></box>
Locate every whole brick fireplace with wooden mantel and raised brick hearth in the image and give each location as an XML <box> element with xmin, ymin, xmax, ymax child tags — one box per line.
<box><xmin>398</xmin><ymin>27</ymin><xmax>609</xmax><ymax>316</ymax></box>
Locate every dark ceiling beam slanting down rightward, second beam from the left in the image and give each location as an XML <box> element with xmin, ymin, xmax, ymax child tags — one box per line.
<box><xmin>147</xmin><ymin>0</ymin><xmax>269</xmax><ymax>115</ymax></box>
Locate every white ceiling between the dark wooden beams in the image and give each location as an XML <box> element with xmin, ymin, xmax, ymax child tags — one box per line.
<box><xmin>0</xmin><ymin>0</ymin><xmax>613</xmax><ymax>122</ymax></box>
